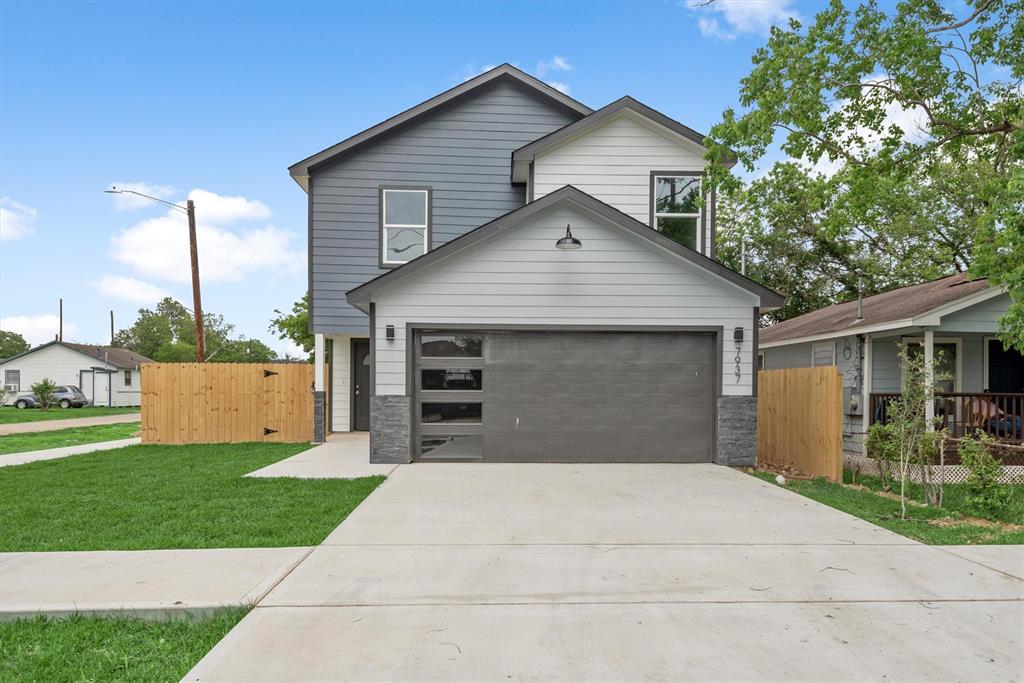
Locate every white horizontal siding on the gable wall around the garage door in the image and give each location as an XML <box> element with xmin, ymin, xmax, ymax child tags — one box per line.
<box><xmin>375</xmin><ymin>206</ymin><xmax>757</xmax><ymax>395</ymax></box>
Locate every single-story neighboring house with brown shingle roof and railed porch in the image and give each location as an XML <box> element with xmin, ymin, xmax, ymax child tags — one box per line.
<box><xmin>760</xmin><ymin>273</ymin><xmax>1024</xmax><ymax>453</ymax></box>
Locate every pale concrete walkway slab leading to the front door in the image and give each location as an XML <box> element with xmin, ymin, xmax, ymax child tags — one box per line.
<box><xmin>246</xmin><ymin>432</ymin><xmax>397</xmax><ymax>479</ymax></box>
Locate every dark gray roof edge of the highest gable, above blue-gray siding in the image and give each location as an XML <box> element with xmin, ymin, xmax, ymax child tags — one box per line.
<box><xmin>288</xmin><ymin>63</ymin><xmax>593</xmax><ymax>178</ymax></box>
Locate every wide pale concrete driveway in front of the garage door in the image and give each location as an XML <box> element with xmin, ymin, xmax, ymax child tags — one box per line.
<box><xmin>186</xmin><ymin>464</ymin><xmax>1024</xmax><ymax>681</ymax></box>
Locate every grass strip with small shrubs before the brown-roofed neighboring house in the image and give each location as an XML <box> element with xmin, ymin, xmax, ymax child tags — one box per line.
<box><xmin>754</xmin><ymin>471</ymin><xmax>1024</xmax><ymax>546</ymax></box>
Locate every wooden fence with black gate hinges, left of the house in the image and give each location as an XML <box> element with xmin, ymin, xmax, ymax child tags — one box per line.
<box><xmin>141</xmin><ymin>362</ymin><xmax>313</xmax><ymax>443</ymax></box>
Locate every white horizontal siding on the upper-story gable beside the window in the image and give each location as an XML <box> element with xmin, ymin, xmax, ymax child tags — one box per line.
<box><xmin>534</xmin><ymin>112</ymin><xmax>711</xmax><ymax>253</ymax></box>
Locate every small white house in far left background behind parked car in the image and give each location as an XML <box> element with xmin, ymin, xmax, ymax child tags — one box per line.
<box><xmin>0</xmin><ymin>341</ymin><xmax>152</xmax><ymax>405</ymax></box>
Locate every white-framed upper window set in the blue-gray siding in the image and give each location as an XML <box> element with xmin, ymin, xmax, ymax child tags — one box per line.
<box><xmin>381</xmin><ymin>187</ymin><xmax>430</xmax><ymax>266</ymax></box>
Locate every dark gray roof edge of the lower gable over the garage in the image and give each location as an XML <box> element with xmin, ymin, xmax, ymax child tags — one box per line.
<box><xmin>345</xmin><ymin>185</ymin><xmax>784</xmax><ymax>310</ymax></box>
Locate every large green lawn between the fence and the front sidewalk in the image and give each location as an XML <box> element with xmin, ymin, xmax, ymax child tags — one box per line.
<box><xmin>0</xmin><ymin>443</ymin><xmax>384</xmax><ymax>552</ymax></box>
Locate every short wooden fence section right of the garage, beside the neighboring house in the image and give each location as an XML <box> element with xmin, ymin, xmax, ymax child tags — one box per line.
<box><xmin>758</xmin><ymin>366</ymin><xmax>843</xmax><ymax>481</ymax></box>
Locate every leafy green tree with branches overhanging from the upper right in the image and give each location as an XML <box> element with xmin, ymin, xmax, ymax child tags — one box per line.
<box><xmin>707</xmin><ymin>0</ymin><xmax>1024</xmax><ymax>349</ymax></box>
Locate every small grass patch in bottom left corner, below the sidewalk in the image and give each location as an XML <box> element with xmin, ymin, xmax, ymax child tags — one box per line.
<box><xmin>0</xmin><ymin>607</ymin><xmax>249</xmax><ymax>682</ymax></box>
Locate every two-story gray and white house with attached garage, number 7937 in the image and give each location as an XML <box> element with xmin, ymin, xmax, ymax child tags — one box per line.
<box><xmin>290</xmin><ymin>65</ymin><xmax>782</xmax><ymax>464</ymax></box>
